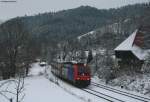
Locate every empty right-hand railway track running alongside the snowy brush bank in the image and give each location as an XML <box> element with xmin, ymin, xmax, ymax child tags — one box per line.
<box><xmin>91</xmin><ymin>82</ymin><xmax>150</xmax><ymax>102</ymax></box>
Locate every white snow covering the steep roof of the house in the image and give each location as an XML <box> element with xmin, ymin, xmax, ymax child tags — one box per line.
<box><xmin>115</xmin><ymin>30</ymin><xmax>148</xmax><ymax>60</ymax></box>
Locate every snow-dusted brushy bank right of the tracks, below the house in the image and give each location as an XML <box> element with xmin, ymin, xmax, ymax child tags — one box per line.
<box><xmin>109</xmin><ymin>74</ymin><xmax>150</xmax><ymax>97</ymax></box>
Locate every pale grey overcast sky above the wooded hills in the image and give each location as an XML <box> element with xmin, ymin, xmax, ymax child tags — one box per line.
<box><xmin>0</xmin><ymin>0</ymin><xmax>150</xmax><ymax>20</ymax></box>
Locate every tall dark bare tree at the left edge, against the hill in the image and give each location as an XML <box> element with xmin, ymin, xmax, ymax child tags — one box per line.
<box><xmin>0</xmin><ymin>18</ymin><xmax>29</xmax><ymax>79</ymax></box>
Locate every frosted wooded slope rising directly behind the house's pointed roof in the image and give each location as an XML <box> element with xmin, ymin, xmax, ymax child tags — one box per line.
<box><xmin>77</xmin><ymin>4</ymin><xmax>150</xmax><ymax>50</ymax></box>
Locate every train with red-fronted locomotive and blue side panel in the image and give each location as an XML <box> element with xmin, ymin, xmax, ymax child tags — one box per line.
<box><xmin>51</xmin><ymin>62</ymin><xmax>91</xmax><ymax>87</ymax></box>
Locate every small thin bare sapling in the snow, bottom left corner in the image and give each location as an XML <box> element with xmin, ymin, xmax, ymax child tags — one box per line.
<box><xmin>0</xmin><ymin>75</ymin><xmax>25</xmax><ymax>102</ymax></box>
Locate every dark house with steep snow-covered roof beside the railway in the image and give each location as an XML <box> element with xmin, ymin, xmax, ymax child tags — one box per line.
<box><xmin>114</xmin><ymin>27</ymin><xmax>150</xmax><ymax>71</ymax></box>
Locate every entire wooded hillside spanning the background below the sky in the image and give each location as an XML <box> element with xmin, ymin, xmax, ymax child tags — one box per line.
<box><xmin>2</xmin><ymin>3</ymin><xmax>150</xmax><ymax>64</ymax></box>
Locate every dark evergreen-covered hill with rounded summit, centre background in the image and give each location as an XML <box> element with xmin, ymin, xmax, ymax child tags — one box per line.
<box><xmin>21</xmin><ymin>6</ymin><xmax>112</xmax><ymax>39</ymax></box>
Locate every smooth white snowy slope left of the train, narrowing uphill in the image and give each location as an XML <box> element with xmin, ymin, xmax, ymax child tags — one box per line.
<box><xmin>0</xmin><ymin>63</ymin><xmax>82</xmax><ymax>102</ymax></box>
